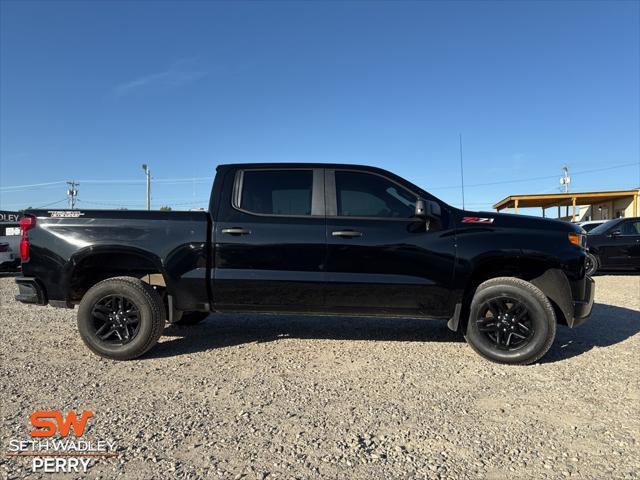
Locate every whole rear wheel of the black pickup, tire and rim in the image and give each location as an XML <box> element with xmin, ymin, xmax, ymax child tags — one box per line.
<box><xmin>78</xmin><ymin>277</ymin><xmax>166</xmax><ymax>360</ymax></box>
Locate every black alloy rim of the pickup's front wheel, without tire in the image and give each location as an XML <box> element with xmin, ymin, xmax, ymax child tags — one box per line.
<box><xmin>476</xmin><ymin>296</ymin><xmax>535</xmax><ymax>350</ymax></box>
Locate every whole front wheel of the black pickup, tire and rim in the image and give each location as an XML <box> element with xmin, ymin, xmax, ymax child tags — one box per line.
<box><xmin>465</xmin><ymin>277</ymin><xmax>556</xmax><ymax>365</ymax></box>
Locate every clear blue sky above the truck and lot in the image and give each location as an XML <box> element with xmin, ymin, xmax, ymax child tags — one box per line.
<box><xmin>0</xmin><ymin>1</ymin><xmax>640</xmax><ymax>209</ymax></box>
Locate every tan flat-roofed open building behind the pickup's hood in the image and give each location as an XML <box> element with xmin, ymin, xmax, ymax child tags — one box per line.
<box><xmin>493</xmin><ymin>189</ymin><xmax>640</xmax><ymax>222</ymax></box>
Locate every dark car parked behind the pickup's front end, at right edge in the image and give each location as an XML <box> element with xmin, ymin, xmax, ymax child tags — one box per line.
<box><xmin>585</xmin><ymin>217</ymin><xmax>640</xmax><ymax>275</ymax></box>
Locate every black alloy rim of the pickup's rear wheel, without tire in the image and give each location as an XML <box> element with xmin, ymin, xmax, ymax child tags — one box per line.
<box><xmin>91</xmin><ymin>295</ymin><xmax>140</xmax><ymax>345</ymax></box>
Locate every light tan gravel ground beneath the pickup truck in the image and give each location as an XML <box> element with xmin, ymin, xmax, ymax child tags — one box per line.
<box><xmin>0</xmin><ymin>276</ymin><xmax>640</xmax><ymax>480</ymax></box>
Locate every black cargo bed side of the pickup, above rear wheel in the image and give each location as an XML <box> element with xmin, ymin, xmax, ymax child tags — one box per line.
<box><xmin>23</xmin><ymin>210</ymin><xmax>210</xmax><ymax>310</ymax></box>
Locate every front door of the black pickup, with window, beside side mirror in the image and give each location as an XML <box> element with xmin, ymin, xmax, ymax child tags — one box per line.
<box><xmin>325</xmin><ymin>169</ymin><xmax>455</xmax><ymax>318</ymax></box>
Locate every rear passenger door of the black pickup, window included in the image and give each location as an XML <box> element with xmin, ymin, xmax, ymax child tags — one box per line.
<box><xmin>212</xmin><ymin>168</ymin><xmax>326</xmax><ymax>311</ymax></box>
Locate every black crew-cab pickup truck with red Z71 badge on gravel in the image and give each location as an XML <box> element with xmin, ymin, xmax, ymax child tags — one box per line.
<box><xmin>16</xmin><ymin>164</ymin><xmax>594</xmax><ymax>364</ymax></box>
